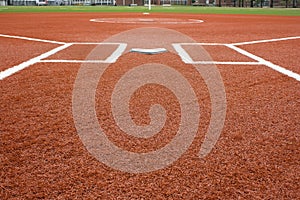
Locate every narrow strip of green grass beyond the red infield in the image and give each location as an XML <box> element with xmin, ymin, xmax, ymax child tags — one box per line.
<box><xmin>0</xmin><ymin>6</ymin><xmax>300</xmax><ymax>16</ymax></box>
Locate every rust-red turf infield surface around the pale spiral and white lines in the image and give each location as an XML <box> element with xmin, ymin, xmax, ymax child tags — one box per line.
<box><xmin>0</xmin><ymin>13</ymin><xmax>300</xmax><ymax>199</ymax></box>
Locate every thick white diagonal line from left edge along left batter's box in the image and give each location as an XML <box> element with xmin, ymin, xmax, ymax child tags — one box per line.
<box><xmin>0</xmin><ymin>44</ymin><xmax>71</xmax><ymax>80</ymax></box>
